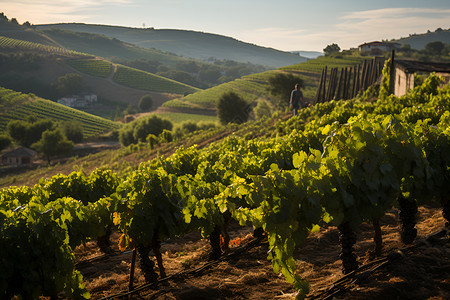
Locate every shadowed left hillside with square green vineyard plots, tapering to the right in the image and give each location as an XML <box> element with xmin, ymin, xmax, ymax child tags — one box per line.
<box><xmin>0</xmin><ymin>36</ymin><xmax>199</xmax><ymax>116</ymax></box>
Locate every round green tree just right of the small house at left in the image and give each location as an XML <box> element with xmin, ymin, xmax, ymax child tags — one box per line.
<box><xmin>31</xmin><ymin>129</ymin><xmax>73</xmax><ymax>164</ymax></box>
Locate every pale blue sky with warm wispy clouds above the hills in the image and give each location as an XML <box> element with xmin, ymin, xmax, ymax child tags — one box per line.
<box><xmin>0</xmin><ymin>0</ymin><xmax>450</xmax><ymax>51</ymax></box>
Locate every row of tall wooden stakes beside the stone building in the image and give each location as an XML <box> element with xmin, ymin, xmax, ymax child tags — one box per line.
<box><xmin>314</xmin><ymin>57</ymin><xmax>385</xmax><ymax>103</ymax></box>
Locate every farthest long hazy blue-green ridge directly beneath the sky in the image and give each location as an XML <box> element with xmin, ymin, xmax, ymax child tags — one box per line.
<box><xmin>37</xmin><ymin>23</ymin><xmax>306</xmax><ymax>68</ymax></box>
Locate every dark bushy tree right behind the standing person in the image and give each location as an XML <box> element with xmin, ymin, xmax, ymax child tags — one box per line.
<box><xmin>268</xmin><ymin>73</ymin><xmax>304</xmax><ymax>109</ymax></box>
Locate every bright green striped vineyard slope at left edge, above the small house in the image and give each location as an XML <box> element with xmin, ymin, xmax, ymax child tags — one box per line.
<box><xmin>0</xmin><ymin>87</ymin><xmax>121</xmax><ymax>138</ymax></box>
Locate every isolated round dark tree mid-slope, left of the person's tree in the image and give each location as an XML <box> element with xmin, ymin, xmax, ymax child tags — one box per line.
<box><xmin>217</xmin><ymin>92</ymin><xmax>251</xmax><ymax>124</ymax></box>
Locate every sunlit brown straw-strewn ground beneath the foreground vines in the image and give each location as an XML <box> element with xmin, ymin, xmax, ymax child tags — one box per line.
<box><xmin>75</xmin><ymin>206</ymin><xmax>450</xmax><ymax>300</ymax></box>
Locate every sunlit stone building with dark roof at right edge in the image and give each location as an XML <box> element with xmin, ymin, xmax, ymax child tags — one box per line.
<box><xmin>392</xmin><ymin>60</ymin><xmax>450</xmax><ymax>97</ymax></box>
